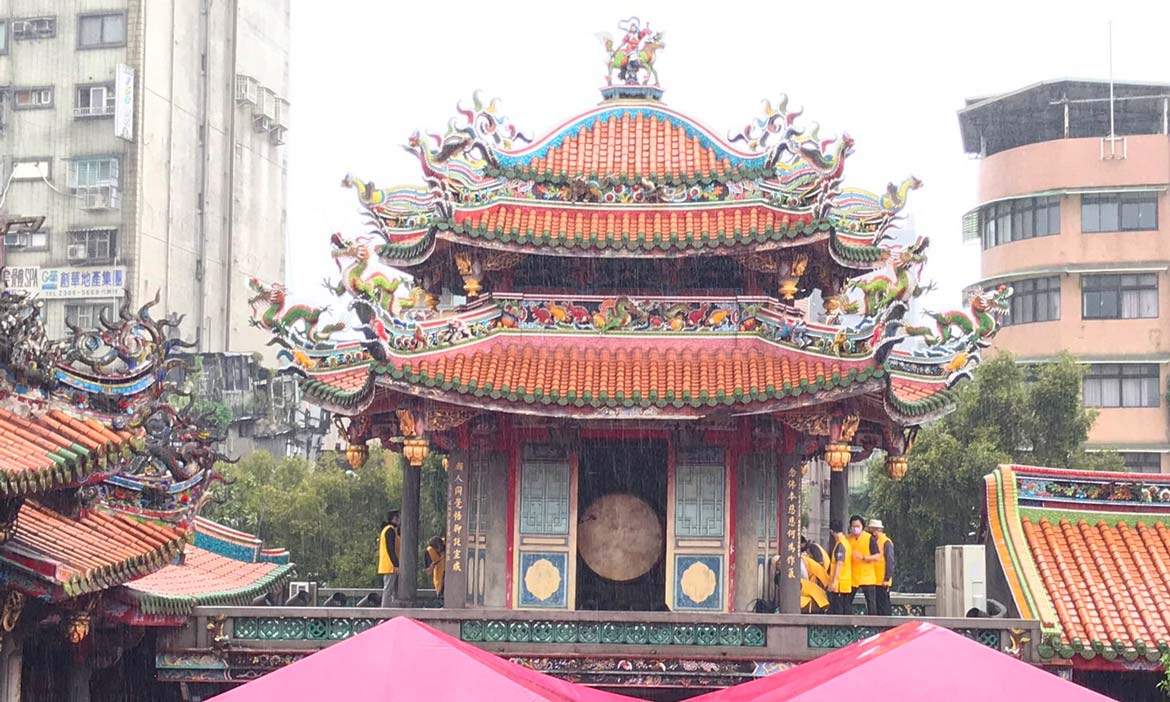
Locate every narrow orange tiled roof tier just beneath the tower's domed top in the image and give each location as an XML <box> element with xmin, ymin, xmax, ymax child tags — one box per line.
<box><xmin>452</xmin><ymin>201</ymin><xmax>818</xmax><ymax>249</ymax></box>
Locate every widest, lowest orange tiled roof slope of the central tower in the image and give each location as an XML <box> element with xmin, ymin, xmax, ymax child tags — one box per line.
<box><xmin>348</xmin><ymin>335</ymin><xmax>885</xmax><ymax>408</ymax></box>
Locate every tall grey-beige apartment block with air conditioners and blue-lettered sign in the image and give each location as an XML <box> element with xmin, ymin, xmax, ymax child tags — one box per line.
<box><xmin>0</xmin><ymin>0</ymin><xmax>290</xmax><ymax>351</ymax></box>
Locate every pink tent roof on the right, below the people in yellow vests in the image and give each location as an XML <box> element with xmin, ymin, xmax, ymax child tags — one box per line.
<box><xmin>693</xmin><ymin>622</ymin><xmax>1109</xmax><ymax>702</ymax></box>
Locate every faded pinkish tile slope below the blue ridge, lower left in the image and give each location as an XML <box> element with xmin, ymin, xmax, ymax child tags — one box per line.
<box><xmin>125</xmin><ymin>544</ymin><xmax>293</xmax><ymax>614</ymax></box>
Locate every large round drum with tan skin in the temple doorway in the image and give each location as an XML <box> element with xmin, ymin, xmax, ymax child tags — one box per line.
<box><xmin>577</xmin><ymin>494</ymin><xmax>663</xmax><ymax>583</ymax></box>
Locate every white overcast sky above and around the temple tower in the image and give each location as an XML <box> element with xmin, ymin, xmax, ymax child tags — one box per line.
<box><xmin>288</xmin><ymin>0</ymin><xmax>1170</xmax><ymax>309</ymax></box>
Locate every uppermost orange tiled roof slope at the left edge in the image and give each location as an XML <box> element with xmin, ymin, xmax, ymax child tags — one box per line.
<box><xmin>0</xmin><ymin>410</ymin><xmax>132</xmax><ymax>495</ymax></box>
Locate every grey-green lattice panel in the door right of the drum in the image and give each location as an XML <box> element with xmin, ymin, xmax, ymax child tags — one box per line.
<box><xmin>674</xmin><ymin>448</ymin><xmax>725</xmax><ymax>536</ymax></box>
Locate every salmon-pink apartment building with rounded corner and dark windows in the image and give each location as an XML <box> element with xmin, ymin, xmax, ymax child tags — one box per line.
<box><xmin>959</xmin><ymin>80</ymin><xmax>1170</xmax><ymax>473</ymax></box>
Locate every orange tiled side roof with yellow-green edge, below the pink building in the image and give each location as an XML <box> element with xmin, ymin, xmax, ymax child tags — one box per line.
<box><xmin>985</xmin><ymin>466</ymin><xmax>1170</xmax><ymax>667</ymax></box>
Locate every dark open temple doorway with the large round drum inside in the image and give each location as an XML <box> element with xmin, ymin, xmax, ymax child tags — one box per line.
<box><xmin>577</xmin><ymin>439</ymin><xmax>667</xmax><ymax>612</ymax></box>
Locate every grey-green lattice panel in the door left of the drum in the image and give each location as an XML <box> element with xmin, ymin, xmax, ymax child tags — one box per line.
<box><xmin>519</xmin><ymin>445</ymin><xmax>569</xmax><ymax>534</ymax></box>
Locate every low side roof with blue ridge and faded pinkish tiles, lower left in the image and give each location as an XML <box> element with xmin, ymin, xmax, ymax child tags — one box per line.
<box><xmin>119</xmin><ymin>517</ymin><xmax>293</xmax><ymax>615</ymax></box>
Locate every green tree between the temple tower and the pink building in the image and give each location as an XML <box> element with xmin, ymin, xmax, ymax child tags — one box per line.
<box><xmin>865</xmin><ymin>353</ymin><xmax>1122</xmax><ymax>592</ymax></box>
